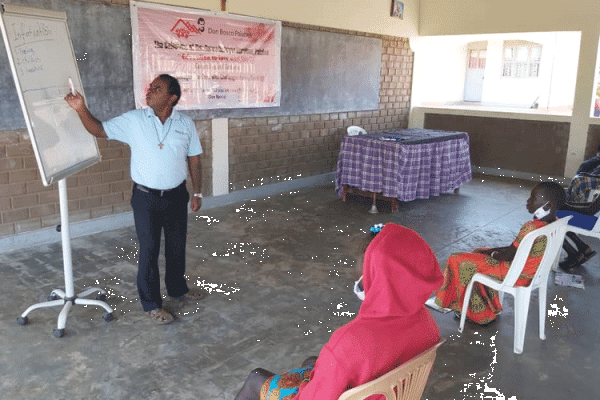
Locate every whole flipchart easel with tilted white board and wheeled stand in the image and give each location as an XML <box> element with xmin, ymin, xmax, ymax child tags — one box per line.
<box><xmin>0</xmin><ymin>4</ymin><xmax>113</xmax><ymax>337</ymax></box>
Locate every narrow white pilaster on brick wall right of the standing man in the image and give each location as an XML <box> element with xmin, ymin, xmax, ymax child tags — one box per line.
<box><xmin>212</xmin><ymin>118</ymin><xmax>229</xmax><ymax>196</ymax></box>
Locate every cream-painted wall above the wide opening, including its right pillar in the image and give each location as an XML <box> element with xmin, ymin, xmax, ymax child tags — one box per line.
<box><xmin>418</xmin><ymin>0</ymin><xmax>600</xmax><ymax>176</ymax></box>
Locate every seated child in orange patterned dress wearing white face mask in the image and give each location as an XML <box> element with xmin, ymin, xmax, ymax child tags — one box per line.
<box><xmin>435</xmin><ymin>182</ymin><xmax>566</xmax><ymax>325</ymax></box>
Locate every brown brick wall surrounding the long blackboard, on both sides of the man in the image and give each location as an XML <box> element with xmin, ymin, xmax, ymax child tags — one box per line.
<box><xmin>0</xmin><ymin>23</ymin><xmax>413</xmax><ymax>236</ymax></box>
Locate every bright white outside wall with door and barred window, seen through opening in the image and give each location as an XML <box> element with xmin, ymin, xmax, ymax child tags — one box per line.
<box><xmin>412</xmin><ymin>32</ymin><xmax>580</xmax><ymax>113</ymax></box>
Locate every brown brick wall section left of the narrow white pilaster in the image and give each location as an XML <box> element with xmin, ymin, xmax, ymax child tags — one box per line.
<box><xmin>0</xmin><ymin>121</ymin><xmax>212</xmax><ymax>236</ymax></box>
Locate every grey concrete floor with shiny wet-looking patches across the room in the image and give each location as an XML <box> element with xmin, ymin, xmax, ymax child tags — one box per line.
<box><xmin>0</xmin><ymin>177</ymin><xmax>600</xmax><ymax>400</ymax></box>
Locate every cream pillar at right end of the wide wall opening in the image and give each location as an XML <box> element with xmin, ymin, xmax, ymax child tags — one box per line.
<box><xmin>554</xmin><ymin>28</ymin><xmax>600</xmax><ymax>177</ymax></box>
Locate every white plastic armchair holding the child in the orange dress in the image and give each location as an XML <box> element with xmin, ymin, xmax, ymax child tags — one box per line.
<box><xmin>458</xmin><ymin>215</ymin><xmax>572</xmax><ymax>354</ymax></box>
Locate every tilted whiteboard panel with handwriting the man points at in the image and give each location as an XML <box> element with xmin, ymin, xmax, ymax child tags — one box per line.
<box><xmin>0</xmin><ymin>4</ymin><xmax>100</xmax><ymax>186</ymax></box>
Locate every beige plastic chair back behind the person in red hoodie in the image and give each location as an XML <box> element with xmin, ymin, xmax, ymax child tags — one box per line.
<box><xmin>338</xmin><ymin>340</ymin><xmax>444</xmax><ymax>400</ymax></box>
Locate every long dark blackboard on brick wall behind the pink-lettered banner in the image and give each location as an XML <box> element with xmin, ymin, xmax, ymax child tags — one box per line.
<box><xmin>0</xmin><ymin>0</ymin><xmax>382</xmax><ymax>131</ymax></box>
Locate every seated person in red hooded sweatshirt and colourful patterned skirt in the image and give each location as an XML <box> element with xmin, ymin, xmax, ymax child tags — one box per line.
<box><xmin>235</xmin><ymin>224</ymin><xmax>442</xmax><ymax>400</ymax></box>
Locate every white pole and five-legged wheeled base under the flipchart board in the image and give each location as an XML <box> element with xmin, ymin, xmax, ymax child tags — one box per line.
<box><xmin>17</xmin><ymin>178</ymin><xmax>114</xmax><ymax>338</ymax></box>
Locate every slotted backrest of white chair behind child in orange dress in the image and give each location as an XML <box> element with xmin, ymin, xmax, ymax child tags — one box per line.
<box><xmin>500</xmin><ymin>215</ymin><xmax>572</xmax><ymax>290</ymax></box>
